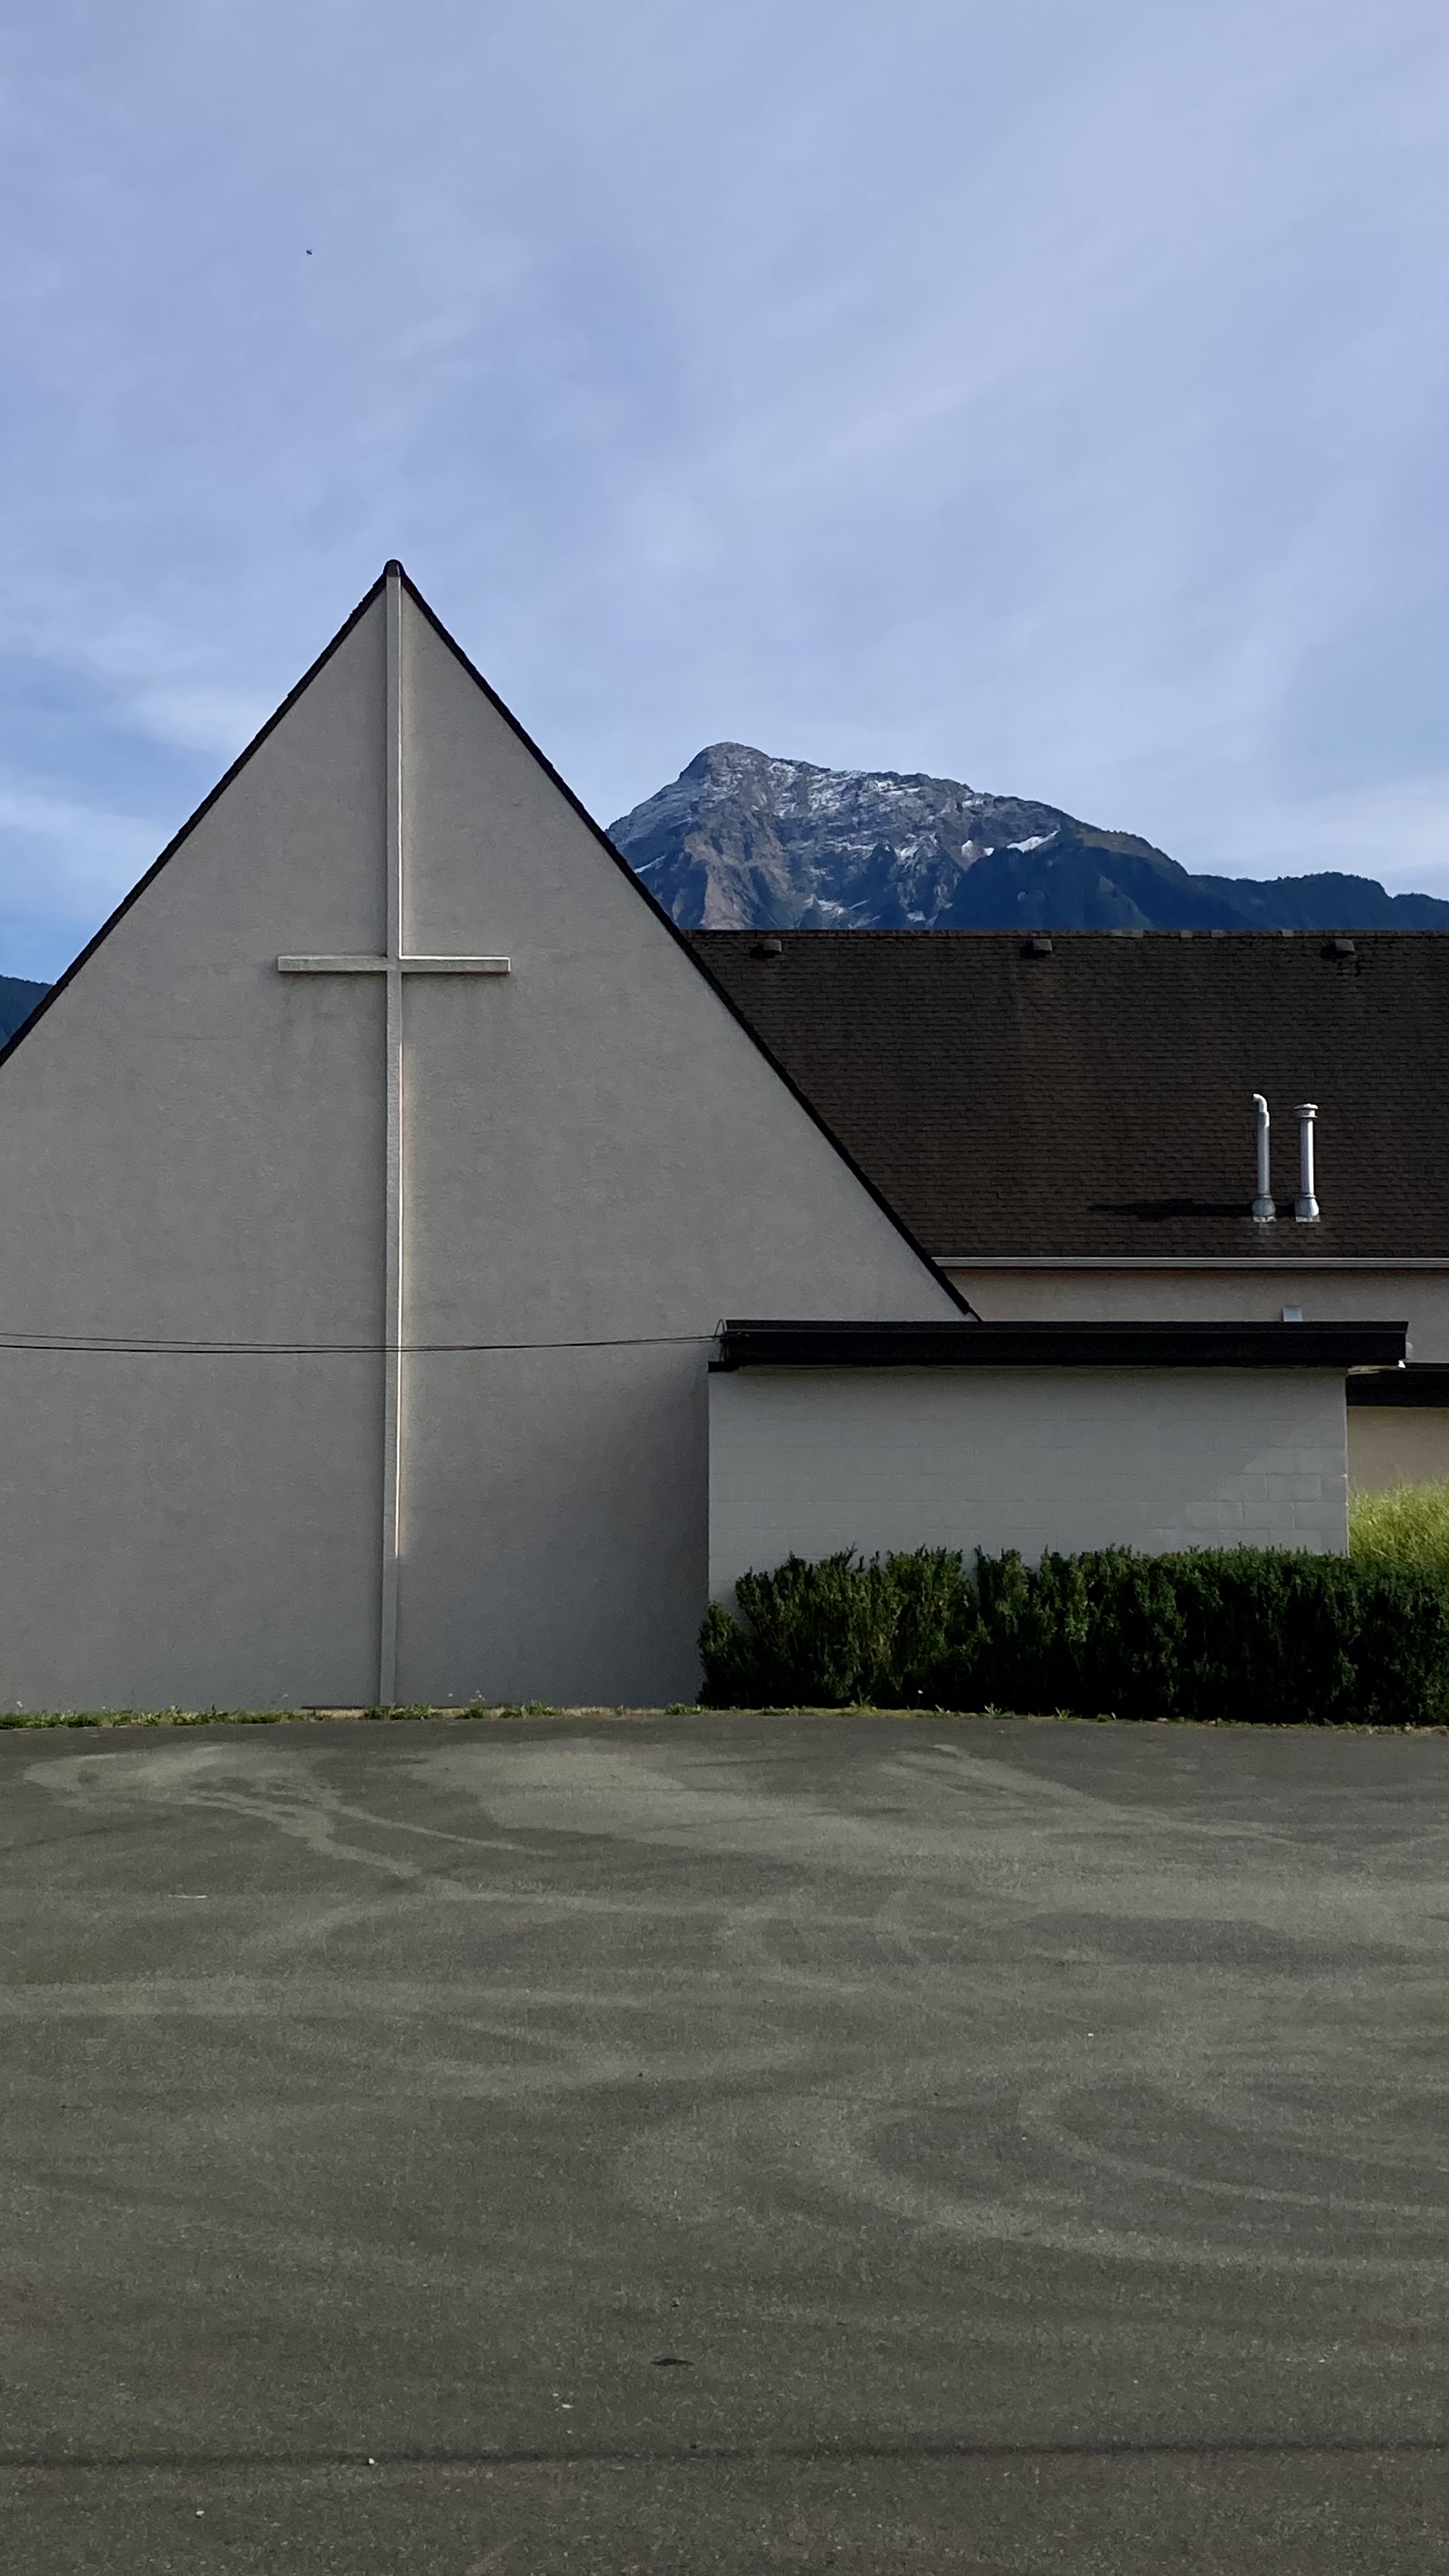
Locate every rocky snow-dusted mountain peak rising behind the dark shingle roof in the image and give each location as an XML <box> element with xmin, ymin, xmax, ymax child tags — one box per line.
<box><xmin>611</xmin><ymin>742</ymin><xmax>1449</xmax><ymax>930</ymax></box>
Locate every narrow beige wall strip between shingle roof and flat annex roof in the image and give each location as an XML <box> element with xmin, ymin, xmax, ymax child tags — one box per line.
<box><xmin>946</xmin><ymin>1262</ymin><xmax>1449</xmax><ymax>1360</ymax></box>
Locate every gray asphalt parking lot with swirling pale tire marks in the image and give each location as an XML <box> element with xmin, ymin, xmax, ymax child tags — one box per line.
<box><xmin>0</xmin><ymin>1718</ymin><xmax>1449</xmax><ymax>2576</ymax></box>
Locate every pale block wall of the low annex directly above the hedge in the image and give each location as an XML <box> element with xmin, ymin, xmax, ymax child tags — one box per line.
<box><xmin>709</xmin><ymin>1368</ymin><xmax>1349</xmax><ymax>1600</ymax></box>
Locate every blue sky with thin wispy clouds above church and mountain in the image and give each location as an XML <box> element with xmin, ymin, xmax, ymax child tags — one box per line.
<box><xmin>0</xmin><ymin>0</ymin><xmax>1449</xmax><ymax>976</ymax></box>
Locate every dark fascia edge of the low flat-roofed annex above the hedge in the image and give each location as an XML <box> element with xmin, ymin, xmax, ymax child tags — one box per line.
<box><xmin>709</xmin><ymin>1319</ymin><xmax>1407</xmax><ymax>1383</ymax></box>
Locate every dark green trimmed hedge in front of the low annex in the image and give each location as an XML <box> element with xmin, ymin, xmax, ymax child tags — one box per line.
<box><xmin>699</xmin><ymin>1548</ymin><xmax>1449</xmax><ymax>1726</ymax></box>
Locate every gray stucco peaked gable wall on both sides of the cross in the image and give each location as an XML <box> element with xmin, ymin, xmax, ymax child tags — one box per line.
<box><xmin>0</xmin><ymin>585</ymin><xmax>954</xmax><ymax>1708</ymax></box>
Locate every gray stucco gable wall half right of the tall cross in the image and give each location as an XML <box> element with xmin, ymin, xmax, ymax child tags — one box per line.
<box><xmin>400</xmin><ymin>608</ymin><xmax>956</xmax><ymax>1700</ymax></box>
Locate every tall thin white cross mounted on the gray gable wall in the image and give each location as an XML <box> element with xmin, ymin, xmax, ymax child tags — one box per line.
<box><xmin>276</xmin><ymin>564</ymin><xmax>510</xmax><ymax>1708</ymax></box>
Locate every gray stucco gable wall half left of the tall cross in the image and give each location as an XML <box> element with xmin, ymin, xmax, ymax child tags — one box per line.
<box><xmin>0</xmin><ymin>608</ymin><xmax>384</xmax><ymax>1708</ymax></box>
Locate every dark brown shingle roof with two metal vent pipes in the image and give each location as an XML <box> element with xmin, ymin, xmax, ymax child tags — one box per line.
<box><xmin>689</xmin><ymin>930</ymin><xmax>1449</xmax><ymax>1262</ymax></box>
